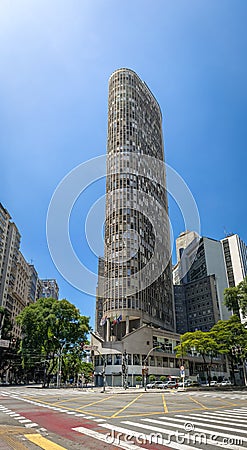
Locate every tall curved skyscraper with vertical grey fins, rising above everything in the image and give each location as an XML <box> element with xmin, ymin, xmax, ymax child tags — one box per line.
<box><xmin>101</xmin><ymin>69</ymin><xmax>174</xmax><ymax>341</ymax></box>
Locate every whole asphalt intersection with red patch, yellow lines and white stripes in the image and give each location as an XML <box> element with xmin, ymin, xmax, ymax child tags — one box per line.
<box><xmin>0</xmin><ymin>387</ymin><xmax>247</xmax><ymax>450</ymax></box>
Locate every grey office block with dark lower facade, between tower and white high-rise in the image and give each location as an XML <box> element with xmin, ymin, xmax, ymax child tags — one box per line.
<box><xmin>174</xmin><ymin>237</ymin><xmax>231</xmax><ymax>333</ymax></box>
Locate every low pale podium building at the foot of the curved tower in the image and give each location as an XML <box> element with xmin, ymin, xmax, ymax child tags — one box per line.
<box><xmin>91</xmin><ymin>325</ymin><xmax>229</xmax><ymax>386</ymax></box>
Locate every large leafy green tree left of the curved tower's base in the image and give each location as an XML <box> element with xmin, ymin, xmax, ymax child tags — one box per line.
<box><xmin>16</xmin><ymin>298</ymin><xmax>90</xmax><ymax>385</ymax></box>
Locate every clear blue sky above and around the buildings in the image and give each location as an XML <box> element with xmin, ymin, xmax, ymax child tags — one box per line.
<box><xmin>0</xmin><ymin>0</ymin><xmax>247</xmax><ymax>324</ymax></box>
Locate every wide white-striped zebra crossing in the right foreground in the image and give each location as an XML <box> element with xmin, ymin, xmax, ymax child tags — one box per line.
<box><xmin>92</xmin><ymin>407</ymin><xmax>247</xmax><ymax>450</ymax></box>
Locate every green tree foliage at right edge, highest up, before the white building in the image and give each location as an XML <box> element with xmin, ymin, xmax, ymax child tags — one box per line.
<box><xmin>224</xmin><ymin>277</ymin><xmax>247</xmax><ymax>318</ymax></box>
